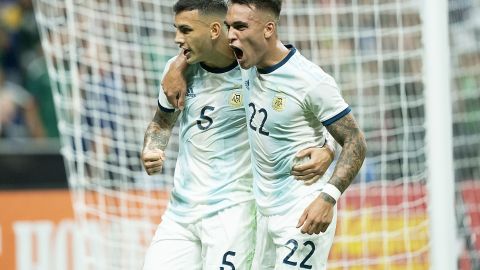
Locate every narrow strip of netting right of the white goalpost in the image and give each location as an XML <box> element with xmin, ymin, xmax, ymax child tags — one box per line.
<box><xmin>449</xmin><ymin>0</ymin><xmax>480</xmax><ymax>269</ymax></box>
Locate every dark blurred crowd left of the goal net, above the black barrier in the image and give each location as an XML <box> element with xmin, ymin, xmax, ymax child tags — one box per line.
<box><xmin>0</xmin><ymin>0</ymin><xmax>58</xmax><ymax>139</ymax></box>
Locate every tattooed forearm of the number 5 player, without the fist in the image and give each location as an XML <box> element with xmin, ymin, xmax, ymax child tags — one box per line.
<box><xmin>143</xmin><ymin>108</ymin><xmax>181</xmax><ymax>150</ymax></box>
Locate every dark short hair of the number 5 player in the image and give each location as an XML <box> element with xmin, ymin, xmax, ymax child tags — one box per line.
<box><xmin>173</xmin><ymin>0</ymin><xmax>227</xmax><ymax>15</ymax></box>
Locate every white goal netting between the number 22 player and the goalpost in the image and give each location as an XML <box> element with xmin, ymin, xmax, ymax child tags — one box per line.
<box><xmin>282</xmin><ymin>1</ymin><xmax>429</xmax><ymax>269</ymax></box>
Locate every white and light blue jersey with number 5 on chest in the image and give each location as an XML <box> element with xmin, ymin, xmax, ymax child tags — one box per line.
<box><xmin>158</xmin><ymin>56</ymin><xmax>253</xmax><ymax>223</ymax></box>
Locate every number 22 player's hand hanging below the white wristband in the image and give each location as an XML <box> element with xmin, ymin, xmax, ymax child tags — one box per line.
<box><xmin>297</xmin><ymin>193</ymin><xmax>335</xmax><ymax>235</ymax></box>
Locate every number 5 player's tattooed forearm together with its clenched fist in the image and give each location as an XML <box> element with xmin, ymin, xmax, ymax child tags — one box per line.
<box><xmin>142</xmin><ymin>108</ymin><xmax>180</xmax><ymax>175</ymax></box>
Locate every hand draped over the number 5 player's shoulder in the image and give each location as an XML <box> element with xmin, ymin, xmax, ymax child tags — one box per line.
<box><xmin>162</xmin><ymin>53</ymin><xmax>187</xmax><ymax>110</ymax></box>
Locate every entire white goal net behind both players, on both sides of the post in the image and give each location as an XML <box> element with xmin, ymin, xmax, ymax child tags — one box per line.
<box><xmin>34</xmin><ymin>0</ymin><xmax>480</xmax><ymax>270</ymax></box>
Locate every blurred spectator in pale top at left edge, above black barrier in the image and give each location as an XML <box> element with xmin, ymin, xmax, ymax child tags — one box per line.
<box><xmin>0</xmin><ymin>67</ymin><xmax>44</xmax><ymax>138</ymax></box>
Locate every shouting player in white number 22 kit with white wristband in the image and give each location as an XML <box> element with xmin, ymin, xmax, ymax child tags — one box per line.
<box><xmin>225</xmin><ymin>0</ymin><xmax>366</xmax><ymax>270</ymax></box>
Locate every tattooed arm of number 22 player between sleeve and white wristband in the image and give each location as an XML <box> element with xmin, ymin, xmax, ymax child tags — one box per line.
<box><xmin>327</xmin><ymin>113</ymin><xmax>367</xmax><ymax>193</ymax></box>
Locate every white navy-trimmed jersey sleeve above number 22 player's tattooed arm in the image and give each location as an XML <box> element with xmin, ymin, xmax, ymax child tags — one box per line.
<box><xmin>305</xmin><ymin>77</ymin><xmax>351</xmax><ymax>126</ymax></box>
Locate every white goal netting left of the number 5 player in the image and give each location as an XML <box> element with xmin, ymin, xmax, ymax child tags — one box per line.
<box><xmin>35</xmin><ymin>0</ymin><xmax>178</xmax><ymax>269</ymax></box>
